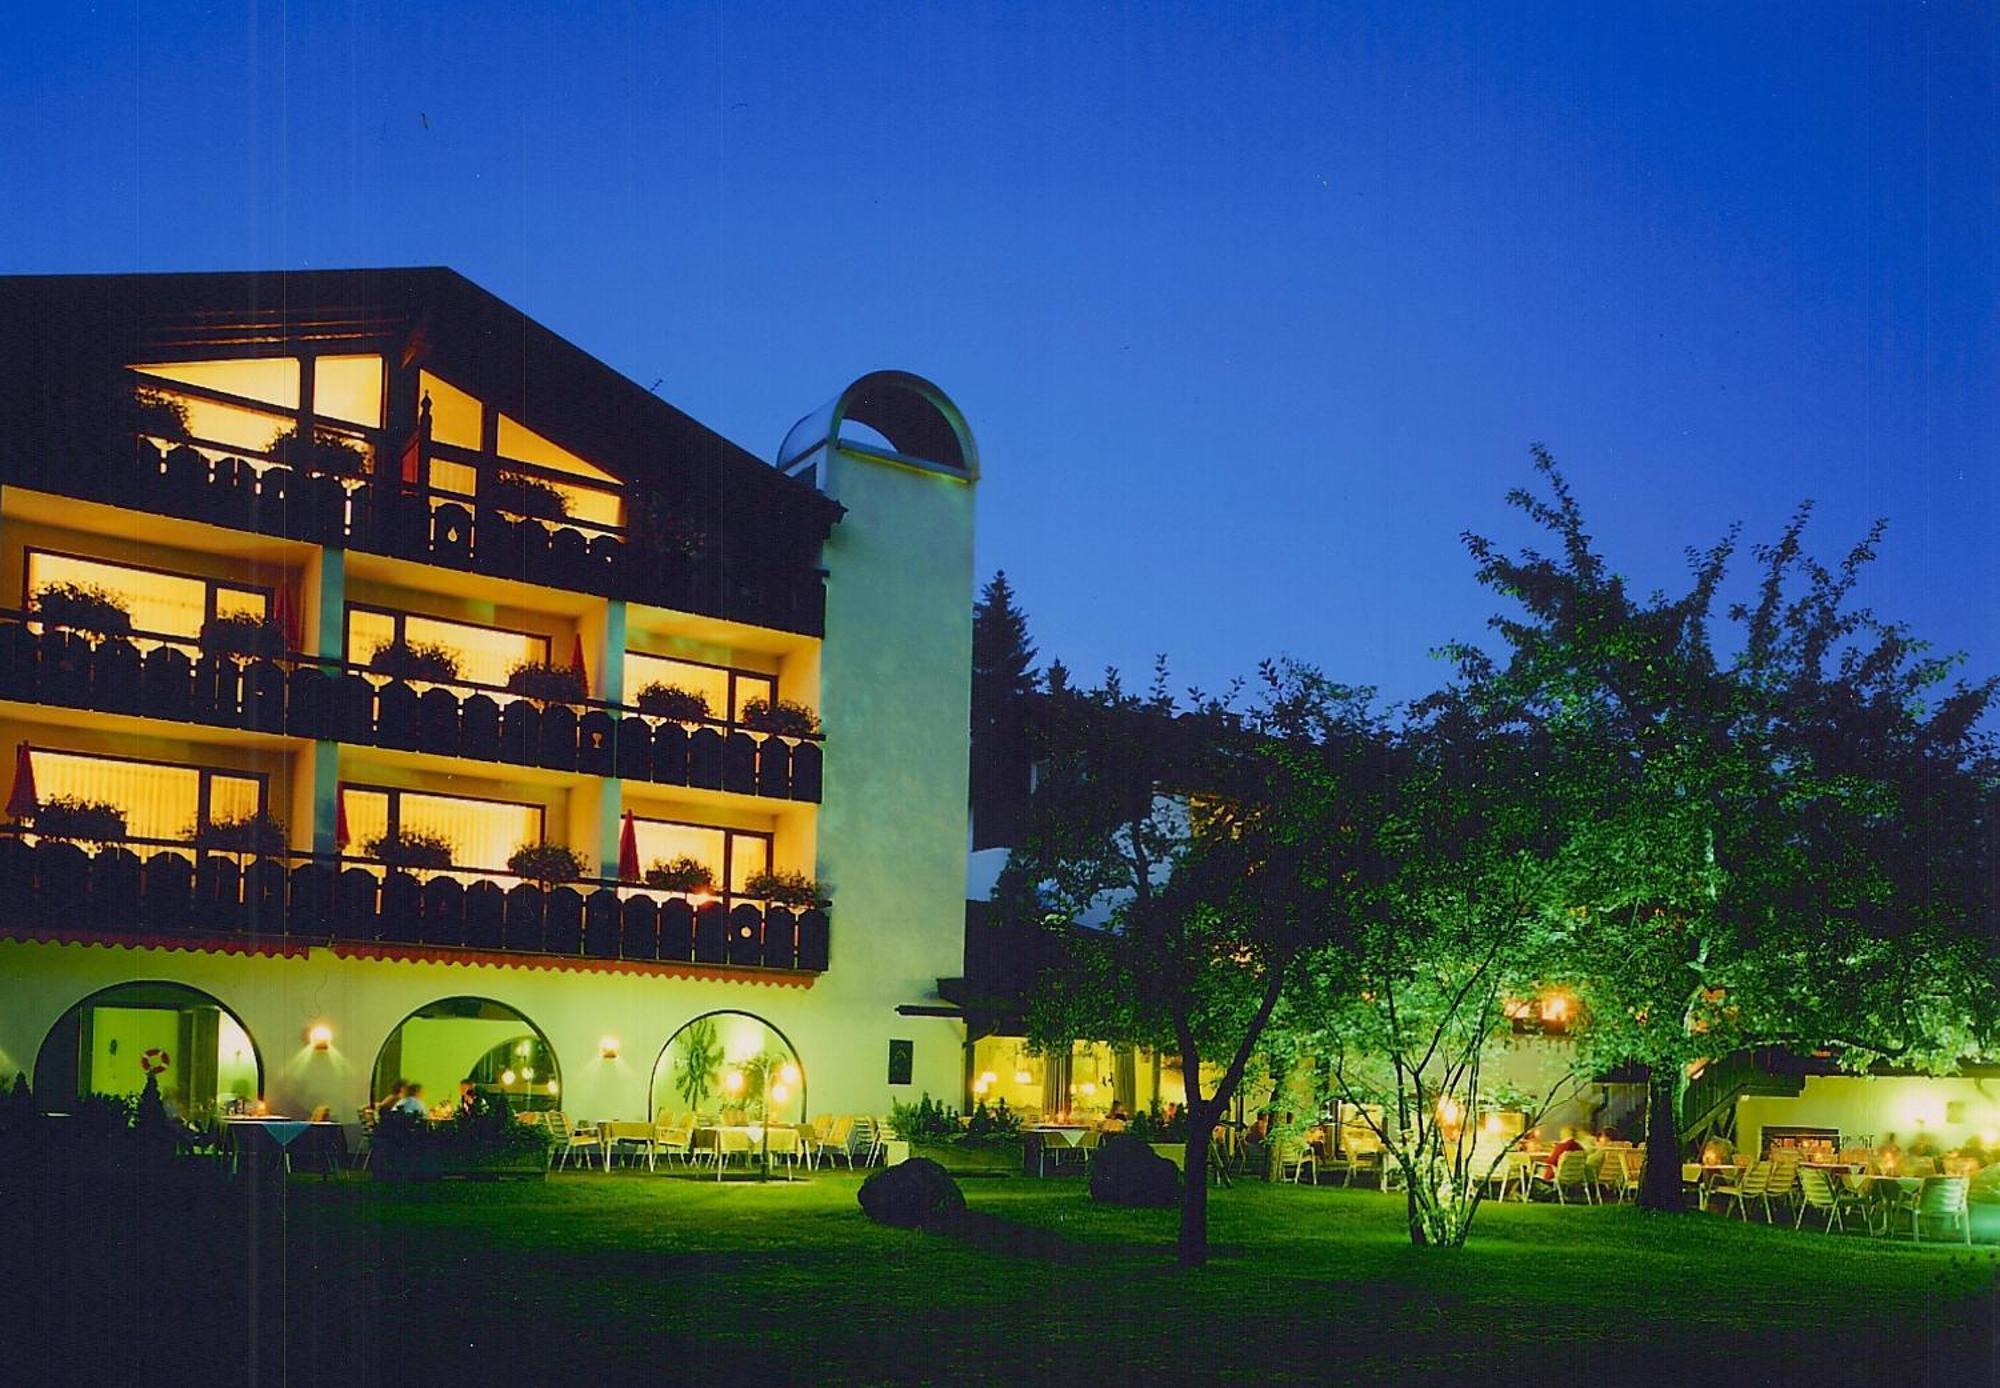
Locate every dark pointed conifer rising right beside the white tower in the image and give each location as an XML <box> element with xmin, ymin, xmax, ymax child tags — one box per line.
<box><xmin>970</xmin><ymin>570</ymin><xmax>1036</xmax><ymax>848</ymax></box>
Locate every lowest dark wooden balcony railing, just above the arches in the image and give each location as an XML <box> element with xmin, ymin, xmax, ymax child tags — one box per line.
<box><xmin>0</xmin><ymin>826</ymin><xmax>828</xmax><ymax>974</ymax></box>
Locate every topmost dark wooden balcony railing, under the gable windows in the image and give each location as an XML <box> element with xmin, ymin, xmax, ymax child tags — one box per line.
<box><xmin>6</xmin><ymin>436</ymin><xmax>826</xmax><ymax>636</ymax></box>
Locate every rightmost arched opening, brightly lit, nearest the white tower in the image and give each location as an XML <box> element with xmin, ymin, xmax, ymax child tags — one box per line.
<box><xmin>650</xmin><ymin>1012</ymin><xmax>806</xmax><ymax>1124</ymax></box>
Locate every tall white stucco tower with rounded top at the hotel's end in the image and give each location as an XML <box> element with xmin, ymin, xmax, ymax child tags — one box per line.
<box><xmin>778</xmin><ymin>372</ymin><xmax>978</xmax><ymax>1102</ymax></box>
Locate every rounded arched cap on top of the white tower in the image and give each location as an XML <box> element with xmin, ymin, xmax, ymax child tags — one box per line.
<box><xmin>778</xmin><ymin>372</ymin><xmax>980</xmax><ymax>480</ymax></box>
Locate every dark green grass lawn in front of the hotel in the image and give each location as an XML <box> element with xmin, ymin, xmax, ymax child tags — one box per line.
<box><xmin>0</xmin><ymin>1172</ymin><xmax>1994</xmax><ymax>1388</ymax></box>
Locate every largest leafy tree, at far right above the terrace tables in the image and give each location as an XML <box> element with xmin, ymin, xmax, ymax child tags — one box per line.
<box><xmin>1458</xmin><ymin>448</ymin><xmax>1994</xmax><ymax>1210</ymax></box>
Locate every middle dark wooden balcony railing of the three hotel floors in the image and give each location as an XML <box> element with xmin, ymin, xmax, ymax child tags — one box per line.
<box><xmin>0</xmin><ymin>610</ymin><xmax>824</xmax><ymax>802</ymax></box>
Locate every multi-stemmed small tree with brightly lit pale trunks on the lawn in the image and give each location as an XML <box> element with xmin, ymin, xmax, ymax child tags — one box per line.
<box><xmin>1276</xmin><ymin>690</ymin><xmax>1580</xmax><ymax>1248</ymax></box>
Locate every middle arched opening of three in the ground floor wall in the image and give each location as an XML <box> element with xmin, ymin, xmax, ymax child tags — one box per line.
<box><xmin>370</xmin><ymin>998</ymin><xmax>562</xmax><ymax>1112</ymax></box>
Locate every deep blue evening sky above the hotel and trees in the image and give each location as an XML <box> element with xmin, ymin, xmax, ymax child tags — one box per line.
<box><xmin>0</xmin><ymin>0</ymin><xmax>2000</xmax><ymax>712</ymax></box>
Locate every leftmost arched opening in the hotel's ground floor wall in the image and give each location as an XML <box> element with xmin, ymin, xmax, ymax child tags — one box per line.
<box><xmin>34</xmin><ymin>982</ymin><xmax>264</xmax><ymax>1118</ymax></box>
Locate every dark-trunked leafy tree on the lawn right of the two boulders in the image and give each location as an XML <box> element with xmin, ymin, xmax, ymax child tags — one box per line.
<box><xmin>996</xmin><ymin>666</ymin><xmax>1380</xmax><ymax>1266</ymax></box>
